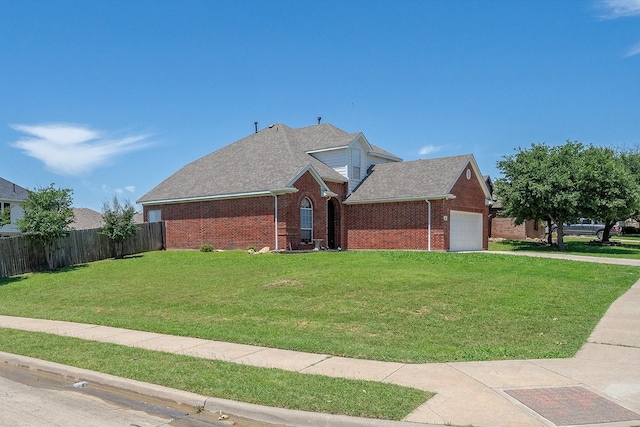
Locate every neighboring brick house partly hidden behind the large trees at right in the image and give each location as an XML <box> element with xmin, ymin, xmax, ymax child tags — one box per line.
<box><xmin>484</xmin><ymin>175</ymin><xmax>545</xmax><ymax>239</ymax></box>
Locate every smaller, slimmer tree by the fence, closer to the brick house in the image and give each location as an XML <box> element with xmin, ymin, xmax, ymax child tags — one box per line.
<box><xmin>100</xmin><ymin>196</ymin><xmax>138</xmax><ymax>259</ymax></box>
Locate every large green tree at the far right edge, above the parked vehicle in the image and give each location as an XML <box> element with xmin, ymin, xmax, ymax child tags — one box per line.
<box><xmin>579</xmin><ymin>145</ymin><xmax>640</xmax><ymax>242</ymax></box>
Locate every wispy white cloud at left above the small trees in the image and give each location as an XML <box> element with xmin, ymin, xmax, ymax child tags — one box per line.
<box><xmin>11</xmin><ymin>124</ymin><xmax>150</xmax><ymax>176</ymax></box>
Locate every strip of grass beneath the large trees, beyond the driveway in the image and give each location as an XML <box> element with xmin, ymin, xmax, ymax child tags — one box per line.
<box><xmin>489</xmin><ymin>236</ymin><xmax>640</xmax><ymax>259</ymax></box>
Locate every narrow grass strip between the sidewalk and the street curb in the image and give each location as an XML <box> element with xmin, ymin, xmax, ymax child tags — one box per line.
<box><xmin>0</xmin><ymin>328</ymin><xmax>433</xmax><ymax>420</ymax></box>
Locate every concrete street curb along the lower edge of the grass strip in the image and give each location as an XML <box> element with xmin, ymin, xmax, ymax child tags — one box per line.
<box><xmin>0</xmin><ymin>351</ymin><xmax>437</xmax><ymax>427</ymax></box>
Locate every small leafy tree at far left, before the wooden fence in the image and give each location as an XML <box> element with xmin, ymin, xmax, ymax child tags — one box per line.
<box><xmin>18</xmin><ymin>184</ymin><xmax>74</xmax><ymax>270</ymax></box>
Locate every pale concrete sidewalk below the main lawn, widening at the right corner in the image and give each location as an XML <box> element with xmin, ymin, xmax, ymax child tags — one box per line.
<box><xmin>0</xmin><ymin>253</ymin><xmax>640</xmax><ymax>427</ymax></box>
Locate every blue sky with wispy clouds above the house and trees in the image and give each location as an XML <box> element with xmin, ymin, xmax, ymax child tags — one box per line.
<box><xmin>0</xmin><ymin>0</ymin><xmax>640</xmax><ymax>211</ymax></box>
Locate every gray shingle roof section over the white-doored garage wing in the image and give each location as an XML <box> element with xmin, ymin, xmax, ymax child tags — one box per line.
<box><xmin>345</xmin><ymin>154</ymin><xmax>475</xmax><ymax>204</ymax></box>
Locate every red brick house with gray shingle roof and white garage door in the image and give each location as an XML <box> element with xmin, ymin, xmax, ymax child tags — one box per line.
<box><xmin>137</xmin><ymin>124</ymin><xmax>490</xmax><ymax>251</ymax></box>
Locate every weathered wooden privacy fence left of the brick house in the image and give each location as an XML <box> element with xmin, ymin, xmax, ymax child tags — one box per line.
<box><xmin>0</xmin><ymin>222</ymin><xmax>165</xmax><ymax>277</ymax></box>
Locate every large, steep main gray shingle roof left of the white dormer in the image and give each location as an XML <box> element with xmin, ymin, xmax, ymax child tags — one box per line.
<box><xmin>138</xmin><ymin>124</ymin><xmax>358</xmax><ymax>203</ymax></box>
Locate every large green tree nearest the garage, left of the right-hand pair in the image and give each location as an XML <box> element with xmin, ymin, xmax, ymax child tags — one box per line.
<box><xmin>496</xmin><ymin>141</ymin><xmax>584</xmax><ymax>251</ymax></box>
